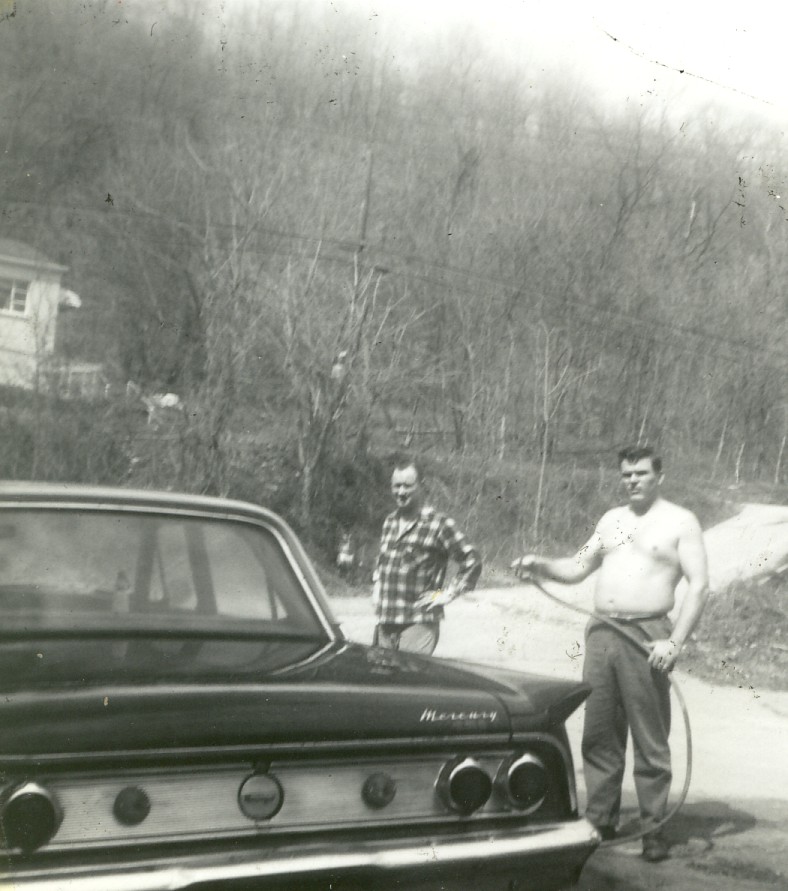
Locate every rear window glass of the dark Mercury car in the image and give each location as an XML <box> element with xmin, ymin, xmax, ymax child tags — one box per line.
<box><xmin>0</xmin><ymin>508</ymin><xmax>322</xmax><ymax>633</ymax></box>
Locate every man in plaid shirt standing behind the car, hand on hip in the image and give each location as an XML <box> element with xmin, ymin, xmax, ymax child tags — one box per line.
<box><xmin>372</xmin><ymin>459</ymin><xmax>482</xmax><ymax>655</ymax></box>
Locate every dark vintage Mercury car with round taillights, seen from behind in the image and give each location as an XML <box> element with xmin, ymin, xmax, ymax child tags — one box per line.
<box><xmin>0</xmin><ymin>483</ymin><xmax>599</xmax><ymax>891</ymax></box>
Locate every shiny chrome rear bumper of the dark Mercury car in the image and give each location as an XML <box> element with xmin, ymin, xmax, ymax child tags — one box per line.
<box><xmin>0</xmin><ymin>819</ymin><xmax>599</xmax><ymax>891</ymax></box>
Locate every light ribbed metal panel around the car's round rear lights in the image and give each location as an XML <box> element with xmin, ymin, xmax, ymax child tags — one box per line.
<box><xmin>0</xmin><ymin>752</ymin><xmax>560</xmax><ymax>857</ymax></box>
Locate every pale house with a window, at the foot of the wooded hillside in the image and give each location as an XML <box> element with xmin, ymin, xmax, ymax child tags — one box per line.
<box><xmin>0</xmin><ymin>238</ymin><xmax>102</xmax><ymax>396</ymax></box>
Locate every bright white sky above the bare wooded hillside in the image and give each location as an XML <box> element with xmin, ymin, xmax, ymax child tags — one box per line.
<box><xmin>346</xmin><ymin>0</ymin><xmax>788</xmax><ymax>120</ymax></box>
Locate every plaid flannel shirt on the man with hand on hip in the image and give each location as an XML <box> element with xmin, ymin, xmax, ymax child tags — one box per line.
<box><xmin>373</xmin><ymin>505</ymin><xmax>482</xmax><ymax>625</ymax></box>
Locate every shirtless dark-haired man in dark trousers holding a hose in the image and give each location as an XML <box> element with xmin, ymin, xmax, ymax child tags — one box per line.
<box><xmin>512</xmin><ymin>447</ymin><xmax>708</xmax><ymax>862</ymax></box>
